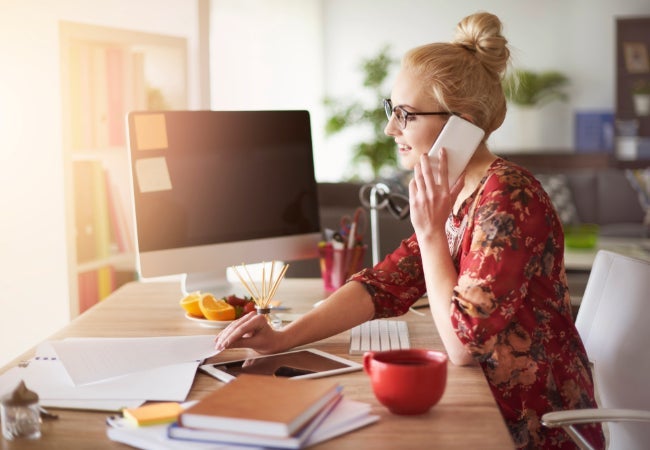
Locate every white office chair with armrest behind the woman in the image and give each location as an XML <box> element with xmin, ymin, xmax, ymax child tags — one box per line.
<box><xmin>542</xmin><ymin>250</ymin><xmax>650</xmax><ymax>450</ymax></box>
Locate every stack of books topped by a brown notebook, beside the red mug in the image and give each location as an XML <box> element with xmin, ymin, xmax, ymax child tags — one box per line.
<box><xmin>167</xmin><ymin>374</ymin><xmax>379</xmax><ymax>449</ymax></box>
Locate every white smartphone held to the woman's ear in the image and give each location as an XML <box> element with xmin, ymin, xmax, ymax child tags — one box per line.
<box><xmin>429</xmin><ymin>116</ymin><xmax>485</xmax><ymax>188</ymax></box>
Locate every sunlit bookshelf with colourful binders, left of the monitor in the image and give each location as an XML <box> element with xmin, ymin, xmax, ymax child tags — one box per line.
<box><xmin>59</xmin><ymin>21</ymin><xmax>187</xmax><ymax>317</ymax></box>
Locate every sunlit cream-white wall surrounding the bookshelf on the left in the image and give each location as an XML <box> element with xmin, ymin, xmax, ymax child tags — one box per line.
<box><xmin>0</xmin><ymin>0</ymin><xmax>199</xmax><ymax>365</ymax></box>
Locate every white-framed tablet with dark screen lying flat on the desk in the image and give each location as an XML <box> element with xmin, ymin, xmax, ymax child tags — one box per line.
<box><xmin>199</xmin><ymin>348</ymin><xmax>363</xmax><ymax>382</ymax></box>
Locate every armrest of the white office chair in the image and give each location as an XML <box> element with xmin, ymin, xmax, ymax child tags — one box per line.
<box><xmin>542</xmin><ymin>408</ymin><xmax>650</xmax><ymax>427</ymax></box>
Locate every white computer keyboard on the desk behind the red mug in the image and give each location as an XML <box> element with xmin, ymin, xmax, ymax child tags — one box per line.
<box><xmin>349</xmin><ymin>319</ymin><xmax>411</xmax><ymax>355</ymax></box>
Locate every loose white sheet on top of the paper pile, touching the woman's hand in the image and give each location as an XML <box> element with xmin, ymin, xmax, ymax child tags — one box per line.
<box><xmin>51</xmin><ymin>335</ymin><xmax>217</xmax><ymax>386</ymax></box>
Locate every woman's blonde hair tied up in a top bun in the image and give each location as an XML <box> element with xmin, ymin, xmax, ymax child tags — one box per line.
<box><xmin>402</xmin><ymin>12</ymin><xmax>510</xmax><ymax>138</ymax></box>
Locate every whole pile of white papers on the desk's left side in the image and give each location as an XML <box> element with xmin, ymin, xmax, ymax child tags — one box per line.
<box><xmin>0</xmin><ymin>335</ymin><xmax>215</xmax><ymax>411</ymax></box>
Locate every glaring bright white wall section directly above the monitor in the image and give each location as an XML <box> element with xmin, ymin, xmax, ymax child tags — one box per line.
<box><xmin>210</xmin><ymin>0</ymin><xmax>328</xmax><ymax>177</ymax></box>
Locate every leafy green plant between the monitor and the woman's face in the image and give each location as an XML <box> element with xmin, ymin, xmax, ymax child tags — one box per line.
<box><xmin>325</xmin><ymin>47</ymin><xmax>397</xmax><ymax>178</ymax></box>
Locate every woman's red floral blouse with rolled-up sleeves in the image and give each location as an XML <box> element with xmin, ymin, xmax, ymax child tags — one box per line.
<box><xmin>351</xmin><ymin>159</ymin><xmax>604</xmax><ymax>449</ymax></box>
